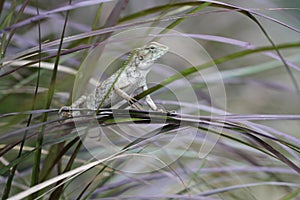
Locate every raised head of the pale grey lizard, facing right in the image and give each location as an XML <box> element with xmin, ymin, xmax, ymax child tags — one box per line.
<box><xmin>134</xmin><ymin>42</ymin><xmax>169</xmax><ymax>69</ymax></box>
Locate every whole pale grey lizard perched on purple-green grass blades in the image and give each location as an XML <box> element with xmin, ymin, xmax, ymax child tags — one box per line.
<box><xmin>58</xmin><ymin>42</ymin><xmax>168</xmax><ymax>117</ymax></box>
